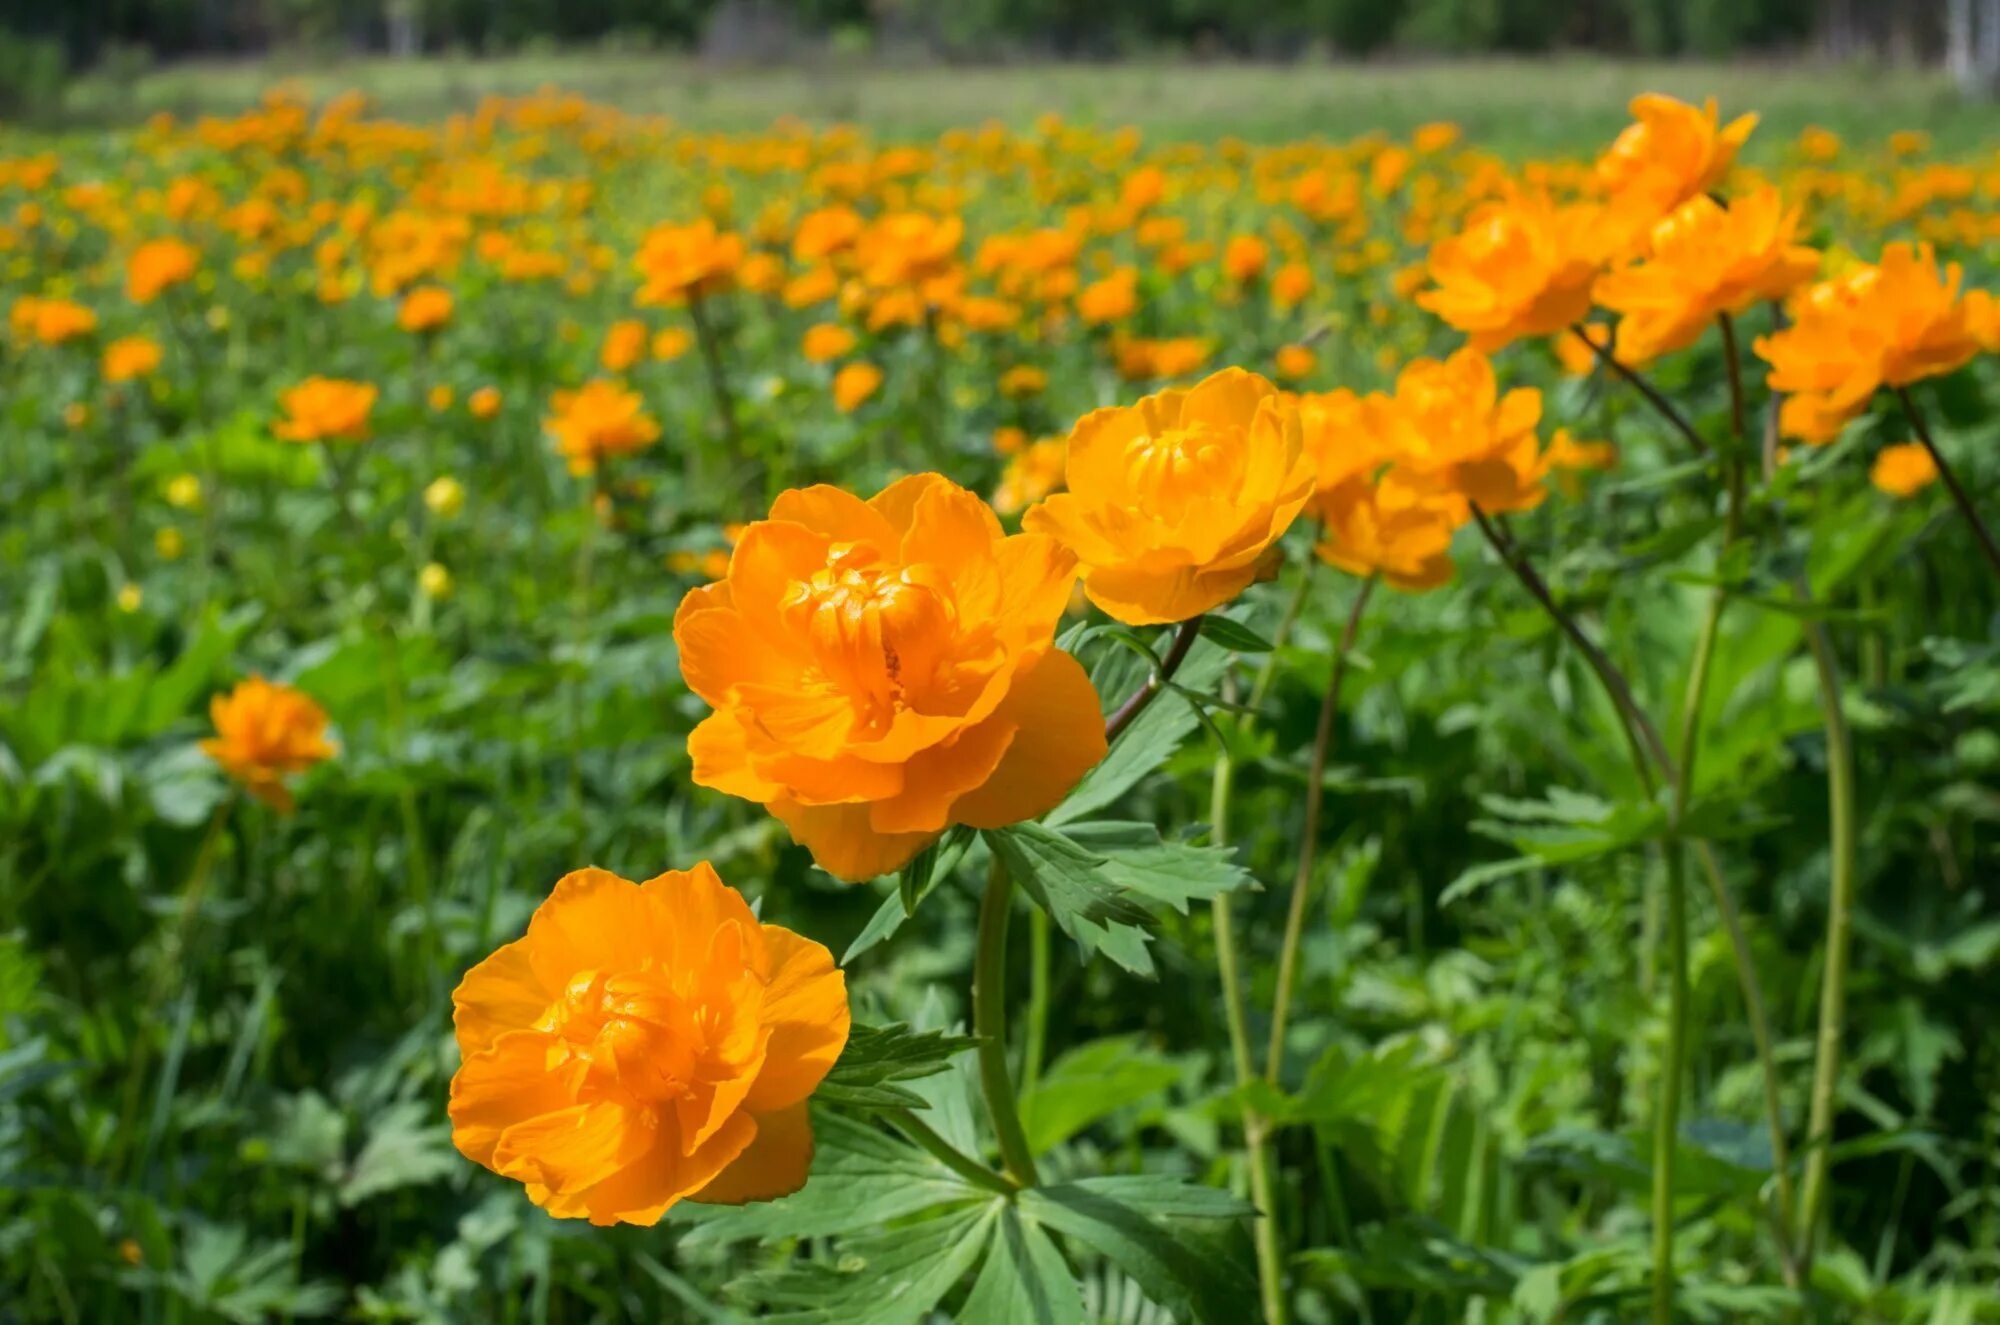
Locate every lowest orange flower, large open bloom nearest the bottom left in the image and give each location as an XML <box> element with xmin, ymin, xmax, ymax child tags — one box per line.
<box><xmin>450</xmin><ymin>861</ymin><xmax>848</xmax><ymax>1225</ymax></box>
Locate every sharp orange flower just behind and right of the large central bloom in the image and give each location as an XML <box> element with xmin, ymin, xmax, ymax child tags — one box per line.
<box><xmin>1022</xmin><ymin>368</ymin><xmax>1312</xmax><ymax>626</ymax></box>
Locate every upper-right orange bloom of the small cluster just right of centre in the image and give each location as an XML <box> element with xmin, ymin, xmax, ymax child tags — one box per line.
<box><xmin>1364</xmin><ymin>348</ymin><xmax>1548</xmax><ymax>512</ymax></box>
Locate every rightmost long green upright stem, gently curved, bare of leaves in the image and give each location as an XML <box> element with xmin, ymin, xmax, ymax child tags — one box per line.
<box><xmin>1798</xmin><ymin>620</ymin><xmax>1854</xmax><ymax>1273</ymax></box>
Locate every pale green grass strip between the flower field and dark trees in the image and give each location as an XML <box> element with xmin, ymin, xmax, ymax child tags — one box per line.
<box><xmin>66</xmin><ymin>52</ymin><xmax>2000</xmax><ymax>152</ymax></box>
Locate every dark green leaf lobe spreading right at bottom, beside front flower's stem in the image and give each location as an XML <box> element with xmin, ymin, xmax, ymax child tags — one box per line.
<box><xmin>1018</xmin><ymin>1177</ymin><xmax>1258</xmax><ymax>1325</ymax></box>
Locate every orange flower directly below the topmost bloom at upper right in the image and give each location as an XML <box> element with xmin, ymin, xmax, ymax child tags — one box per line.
<box><xmin>1596</xmin><ymin>188</ymin><xmax>1820</xmax><ymax>364</ymax></box>
